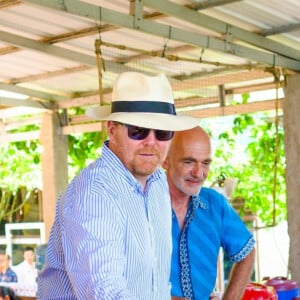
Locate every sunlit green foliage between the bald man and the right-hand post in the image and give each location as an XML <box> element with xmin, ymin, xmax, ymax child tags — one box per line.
<box><xmin>211</xmin><ymin>115</ymin><xmax>287</xmax><ymax>226</ymax></box>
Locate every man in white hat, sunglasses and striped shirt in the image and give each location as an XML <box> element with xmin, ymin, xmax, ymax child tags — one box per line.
<box><xmin>38</xmin><ymin>72</ymin><xmax>199</xmax><ymax>300</ymax></box>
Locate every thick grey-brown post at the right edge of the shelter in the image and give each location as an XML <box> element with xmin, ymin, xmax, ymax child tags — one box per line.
<box><xmin>283</xmin><ymin>74</ymin><xmax>300</xmax><ymax>283</ymax></box>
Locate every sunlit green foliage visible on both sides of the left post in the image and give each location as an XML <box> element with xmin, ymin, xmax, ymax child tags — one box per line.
<box><xmin>0</xmin><ymin>132</ymin><xmax>105</xmax><ymax>190</ymax></box>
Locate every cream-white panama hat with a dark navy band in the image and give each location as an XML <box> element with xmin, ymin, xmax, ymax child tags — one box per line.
<box><xmin>86</xmin><ymin>72</ymin><xmax>200</xmax><ymax>131</ymax></box>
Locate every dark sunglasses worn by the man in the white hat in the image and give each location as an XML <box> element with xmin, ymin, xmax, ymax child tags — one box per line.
<box><xmin>123</xmin><ymin>124</ymin><xmax>174</xmax><ymax>141</ymax></box>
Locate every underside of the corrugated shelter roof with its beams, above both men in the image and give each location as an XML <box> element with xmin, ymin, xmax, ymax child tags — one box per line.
<box><xmin>0</xmin><ymin>0</ymin><xmax>300</xmax><ymax>141</ymax></box>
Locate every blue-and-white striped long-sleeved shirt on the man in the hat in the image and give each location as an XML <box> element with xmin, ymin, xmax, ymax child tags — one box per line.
<box><xmin>38</xmin><ymin>143</ymin><xmax>172</xmax><ymax>300</ymax></box>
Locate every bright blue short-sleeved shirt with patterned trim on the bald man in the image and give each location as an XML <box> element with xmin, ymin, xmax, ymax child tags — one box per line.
<box><xmin>171</xmin><ymin>188</ymin><xmax>254</xmax><ymax>300</ymax></box>
